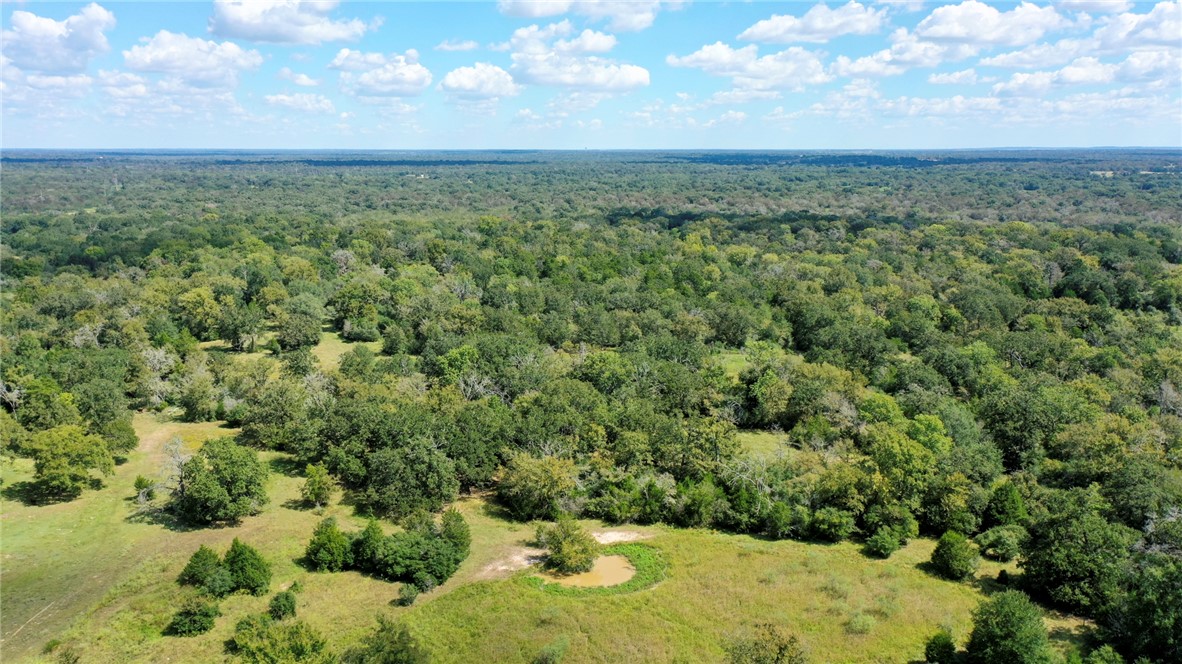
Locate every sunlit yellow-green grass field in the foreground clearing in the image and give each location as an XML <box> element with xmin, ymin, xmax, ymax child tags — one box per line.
<box><xmin>0</xmin><ymin>333</ymin><xmax>1087</xmax><ymax>663</ymax></box>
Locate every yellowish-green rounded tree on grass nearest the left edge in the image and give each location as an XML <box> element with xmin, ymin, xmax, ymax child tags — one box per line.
<box><xmin>28</xmin><ymin>424</ymin><xmax>115</xmax><ymax>499</ymax></box>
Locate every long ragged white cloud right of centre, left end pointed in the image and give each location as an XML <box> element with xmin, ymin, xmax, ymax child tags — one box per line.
<box><xmin>665</xmin><ymin>41</ymin><xmax>833</xmax><ymax>90</ymax></box>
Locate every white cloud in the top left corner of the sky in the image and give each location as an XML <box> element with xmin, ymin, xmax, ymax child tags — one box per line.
<box><xmin>2</xmin><ymin>2</ymin><xmax>115</xmax><ymax>74</ymax></box>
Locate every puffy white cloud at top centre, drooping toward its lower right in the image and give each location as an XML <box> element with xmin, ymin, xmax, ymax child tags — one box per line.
<box><xmin>504</xmin><ymin>20</ymin><xmax>649</xmax><ymax>91</ymax></box>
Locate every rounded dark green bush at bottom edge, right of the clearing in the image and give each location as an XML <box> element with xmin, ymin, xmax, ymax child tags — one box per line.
<box><xmin>966</xmin><ymin>591</ymin><xmax>1052</xmax><ymax>664</ymax></box>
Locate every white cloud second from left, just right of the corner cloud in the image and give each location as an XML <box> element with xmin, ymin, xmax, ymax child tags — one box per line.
<box><xmin>123</xmin><ymin>30</ymin><xmax>262</xmax><ymax>86</ymax></box>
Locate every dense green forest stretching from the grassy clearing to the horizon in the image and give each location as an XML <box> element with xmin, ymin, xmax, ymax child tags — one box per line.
<box><xmin>0</xmin><ymin>150</ymin><xmax>1182</xmax><ymax>663</ymax></box>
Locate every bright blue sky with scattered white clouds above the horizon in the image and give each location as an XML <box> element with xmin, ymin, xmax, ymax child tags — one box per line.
<box><xmin>0</xmin><ymin>0</ymin><xmax>1182</xmax><ymax>149</ymax></box>
